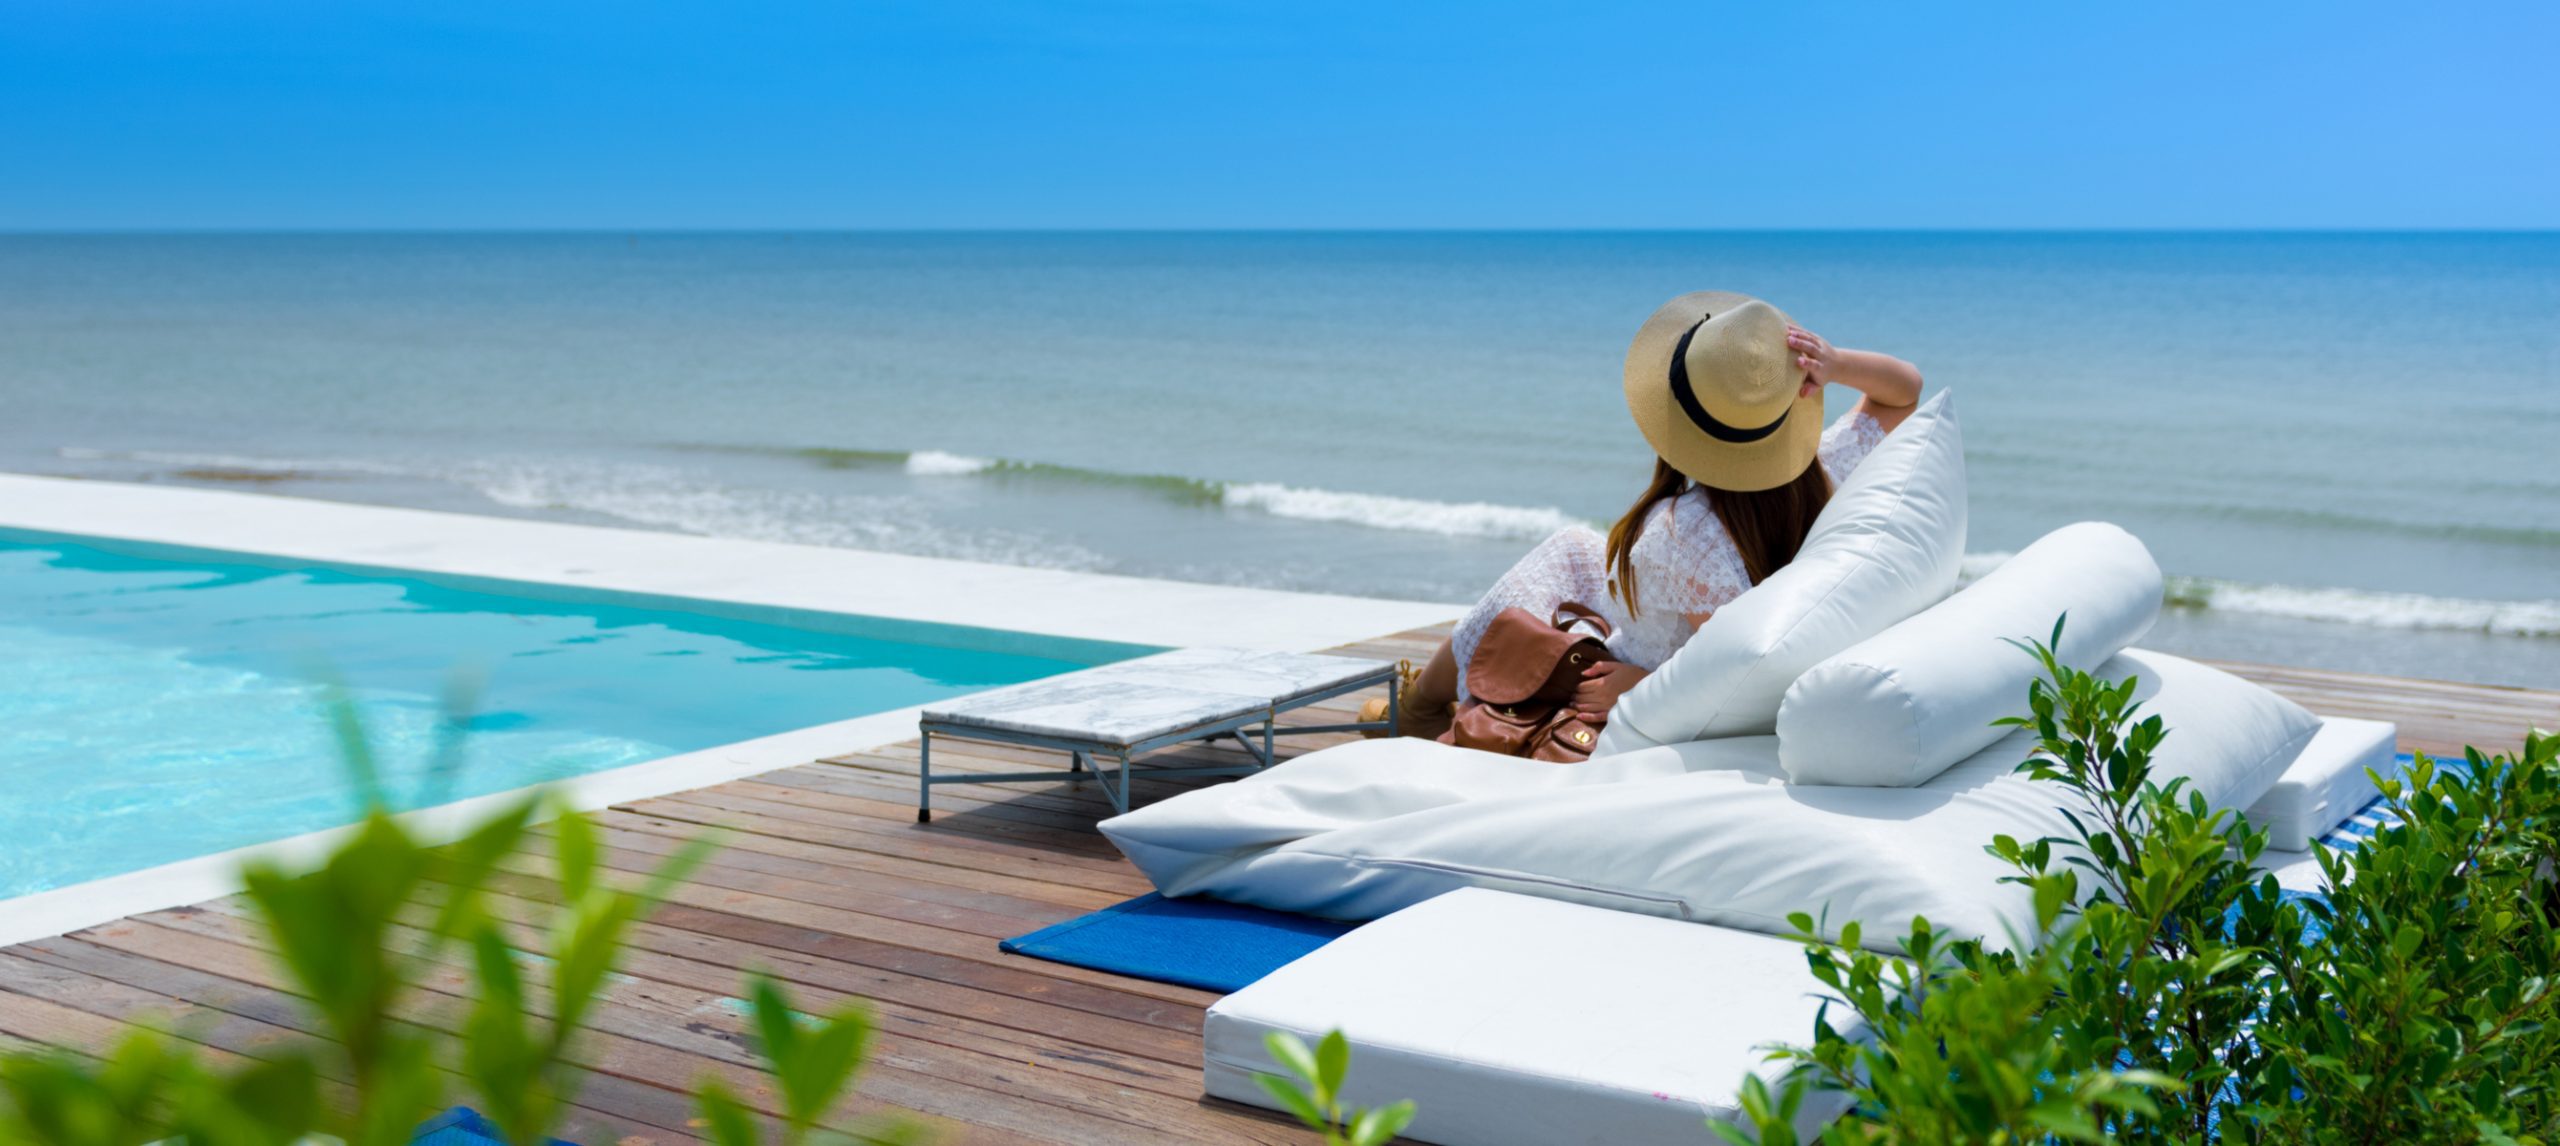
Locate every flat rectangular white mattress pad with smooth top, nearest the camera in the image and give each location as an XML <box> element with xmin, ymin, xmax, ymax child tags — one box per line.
<box><xmin>1203</xmin><ymin>890</ymin><xmax>1856</xmax><ymax>1146</ymax></box>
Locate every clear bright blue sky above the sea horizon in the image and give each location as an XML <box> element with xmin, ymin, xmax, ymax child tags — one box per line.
<box><xmin>0</xmin><ymin>0</ymin><xmax>2560</xmax><ymax>230</ymax></box>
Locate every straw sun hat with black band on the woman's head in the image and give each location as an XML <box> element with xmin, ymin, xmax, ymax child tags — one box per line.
<box><xmin>1626</xmin><ymin>292</ymin><xmax>1823</xmax><ymax>494</ymax></box>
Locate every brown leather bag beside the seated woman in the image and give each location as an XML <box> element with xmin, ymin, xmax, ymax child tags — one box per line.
<box><xmin>1441</xmin><ymin>601</ymin><xmax>1644</xmax><ymax>765</ymax></box>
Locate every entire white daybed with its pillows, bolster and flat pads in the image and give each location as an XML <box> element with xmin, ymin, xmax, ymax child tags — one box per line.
<box><xmin>1103</xmin><ymin>394</ymin><xmax>2394</xmax><ymax>1146</ymax></box>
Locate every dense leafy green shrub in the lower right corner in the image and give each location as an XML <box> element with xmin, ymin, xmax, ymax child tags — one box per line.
<box><xmin>1718</xmin><ymin>627</ymin><xmax>2560</xmax><ymax>1146</ymax></box>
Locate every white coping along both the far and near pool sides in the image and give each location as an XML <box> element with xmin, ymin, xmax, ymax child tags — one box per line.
<box><xmin>0</xmin><ymin>473</ymin><xmax>1464</xmax><ymax>946</ymax></box>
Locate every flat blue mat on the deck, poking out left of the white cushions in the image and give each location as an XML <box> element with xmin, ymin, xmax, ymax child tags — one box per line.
<box><xmin>1004</xmin><ymin>893</ymin><xmax>1359</xmax><ymax>993</ymax></box>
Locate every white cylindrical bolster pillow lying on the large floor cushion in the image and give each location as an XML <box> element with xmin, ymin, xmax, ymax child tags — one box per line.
<box><xmin>1777</xmin><ymin>522</ymin><xmax>2161</xmax><ymax>788</ymax></box>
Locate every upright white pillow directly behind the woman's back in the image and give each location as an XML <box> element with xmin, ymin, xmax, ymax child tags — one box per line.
<box><xmin>1595</xmin><ymin>394</ymin><xmax>1966</xmax><ymax>755</ymax></box>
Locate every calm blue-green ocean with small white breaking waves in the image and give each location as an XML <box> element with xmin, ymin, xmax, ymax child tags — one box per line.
<box><xmin>0</xmin><ymin>233</ymin><xmax>2560</xmax><ymax>688</ymax></box>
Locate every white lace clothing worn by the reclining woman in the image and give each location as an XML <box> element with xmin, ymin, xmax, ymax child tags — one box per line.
<box><xmin>1452</xmin><ymin>409</ymin><xmax>1884</xmax><ymax>696</ymax></box>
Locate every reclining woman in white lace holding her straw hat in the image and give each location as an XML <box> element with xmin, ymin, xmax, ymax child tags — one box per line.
<box><xmin>1364</xmin><ymin>292</ymin><xmax>1920</xmax><ymax>737</ymax></box>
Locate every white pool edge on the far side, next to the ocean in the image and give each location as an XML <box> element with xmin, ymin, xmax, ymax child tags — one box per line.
<box><xmin>0</xmin><ymin>473</ymin><xmax>1464</xmax><ymax>652</ymax></box>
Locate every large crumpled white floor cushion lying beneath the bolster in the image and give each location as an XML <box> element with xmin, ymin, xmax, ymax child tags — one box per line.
<box><xmin>1101</xmin><ymin>650</ymin><xmax>2319</xmax><ymax>949</ymax></box>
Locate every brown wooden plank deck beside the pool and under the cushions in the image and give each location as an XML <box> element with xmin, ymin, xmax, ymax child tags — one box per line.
<box><xmin>0</xmin><ymin>632</ymin><xmax>2560</xmax><ymax>1146</ymax></box>
